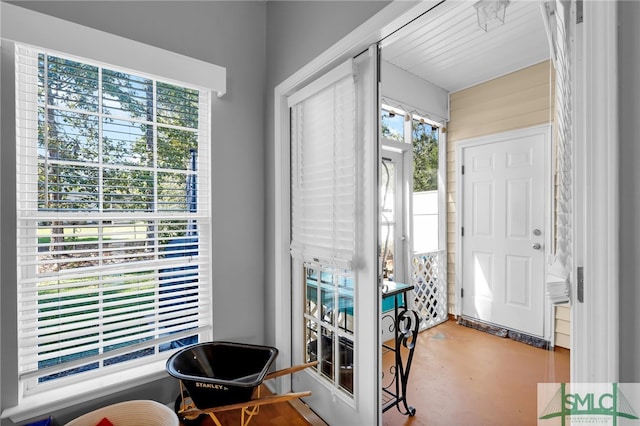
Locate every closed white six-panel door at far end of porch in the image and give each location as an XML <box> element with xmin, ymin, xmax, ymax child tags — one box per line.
<box><xmin>460</xmin><ymin>127</ymin><xmax>549</xmax><ymax>337</ymax></box>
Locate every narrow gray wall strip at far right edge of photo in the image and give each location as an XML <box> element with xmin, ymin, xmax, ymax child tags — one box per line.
<box><xmin>618</xmin><ymin>1</ymin><xmax>640</xmax><ymax>383</ymax></box>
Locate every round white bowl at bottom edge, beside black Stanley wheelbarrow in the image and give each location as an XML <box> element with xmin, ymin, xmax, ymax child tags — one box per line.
<box><xmin>66</xmin><ymin>400</ymin><xmax>180</xmax><ymax>426</ymax></box>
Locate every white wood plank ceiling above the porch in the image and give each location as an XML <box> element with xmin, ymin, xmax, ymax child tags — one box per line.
<box><xmin>382</xmin><ymin>0</ymin><xmax>549</xmax><ymax>92</ymax></box>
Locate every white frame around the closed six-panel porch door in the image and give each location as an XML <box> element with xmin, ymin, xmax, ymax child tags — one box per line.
<box><xmin>454</xmin><ymin>124</ymin><xmax>554</xmax><ymax>345</ymax></box>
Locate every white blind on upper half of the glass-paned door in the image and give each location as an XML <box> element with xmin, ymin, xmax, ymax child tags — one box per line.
<box><xmin>289</xmin><ymin>62</ymin><xmax>357</xmax><ymax>270</ymax></box>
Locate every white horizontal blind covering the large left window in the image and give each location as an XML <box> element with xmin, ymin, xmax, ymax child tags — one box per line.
<box><xmin>16</xmin><ymin>45</ymin><xmax>211</xmax><ymax>392</ymax></box>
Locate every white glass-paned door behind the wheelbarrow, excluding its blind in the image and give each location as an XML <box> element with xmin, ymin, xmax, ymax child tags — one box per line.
<box><xmin>291</xmin><ymin>46</ymin><xmax>382</xmax><ymax>426</ymax></box>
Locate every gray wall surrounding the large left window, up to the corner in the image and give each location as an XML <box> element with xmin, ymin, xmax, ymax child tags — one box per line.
<box><xmin>0</xmin><ymin>1</ymin><xmax>266</xmax><ymax>426</ymax></box>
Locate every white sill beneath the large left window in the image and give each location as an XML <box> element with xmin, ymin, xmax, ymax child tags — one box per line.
<box><xmin>0</xmin><ymin>361</ymin><xmax>168</xmax><ymax>423</ymax></box>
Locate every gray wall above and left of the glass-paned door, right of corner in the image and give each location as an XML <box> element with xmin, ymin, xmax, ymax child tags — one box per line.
<box><xmin>264</xmin><ymin>0</ymin><xmax>390</xmax><ymax>360</ymax></box>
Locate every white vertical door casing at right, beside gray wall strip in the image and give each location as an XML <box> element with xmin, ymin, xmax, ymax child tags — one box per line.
<box><xmin>571</xmin><ymin>1</ymin><xmax>620</xmax><ymax>383</ymax></box>
